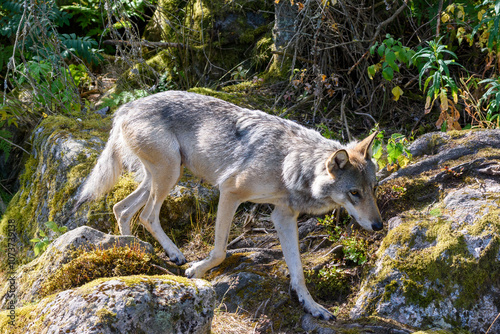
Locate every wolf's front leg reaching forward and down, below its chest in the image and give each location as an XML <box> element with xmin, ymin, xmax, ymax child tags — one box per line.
<box><xmin>271</xmin><ymin>206</ymin><xmax>335</xmax><ymax>320</ymax></box>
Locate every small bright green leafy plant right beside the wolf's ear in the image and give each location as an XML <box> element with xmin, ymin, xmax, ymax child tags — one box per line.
<box><xmin>372</xmin><ymin>130</ymin><xmax>412</xmax><ymax>171</ymax></box>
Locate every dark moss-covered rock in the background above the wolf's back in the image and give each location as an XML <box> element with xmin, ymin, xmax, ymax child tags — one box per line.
<box><xmin>139</xmin><ymin>0</ymin><xmax>274</xmax><ymax>88</ymax></box>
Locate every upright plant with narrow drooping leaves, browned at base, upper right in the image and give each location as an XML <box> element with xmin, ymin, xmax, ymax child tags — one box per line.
<box><xmin>412</xmin><ymin>38</ymin><xmax>462</xmax><ymax>130</ymax></box>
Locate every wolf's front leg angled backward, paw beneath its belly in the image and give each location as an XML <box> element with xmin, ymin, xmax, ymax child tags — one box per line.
<box><xmin>186</xmin><ymin>189</ymin><xmax>240</xmax><ymax>278</ymax></box>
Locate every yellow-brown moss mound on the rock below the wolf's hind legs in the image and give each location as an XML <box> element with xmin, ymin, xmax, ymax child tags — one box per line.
<box><xmin>40</xmin><ymin>244</ymin><xmax>165</xmax><ymax>296</ymax></box>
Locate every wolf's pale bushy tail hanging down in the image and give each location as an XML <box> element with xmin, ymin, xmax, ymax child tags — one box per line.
<box><xmin>73</xmin><ymin>118</ymin><xmax>125</xmax><ymax>212</ymax></box>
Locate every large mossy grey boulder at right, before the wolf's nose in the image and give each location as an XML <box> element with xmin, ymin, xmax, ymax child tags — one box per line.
<box><xmin>350</xmin><ymin>130</ymin><xmax>500</xmax><ymax>333</ymax></box>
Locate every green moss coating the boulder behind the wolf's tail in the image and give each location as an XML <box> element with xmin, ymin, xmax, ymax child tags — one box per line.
<box><xmin>0</xmin><ymin>115</ymin><xmax>111</xmax><ymax>272</ymax></box>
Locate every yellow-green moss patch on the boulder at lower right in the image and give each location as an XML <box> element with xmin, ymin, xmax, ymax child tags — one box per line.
<box><xmin>370</xmin><ymin>209</ymin><xmax>500</xmax><ymax>309</ymax></box>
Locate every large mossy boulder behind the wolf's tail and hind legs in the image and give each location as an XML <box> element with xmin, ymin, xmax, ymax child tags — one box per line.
<box><xmin>0</xmin><ymin>115</ymin><xmax>218</xmax><ymax>266</ymax></box>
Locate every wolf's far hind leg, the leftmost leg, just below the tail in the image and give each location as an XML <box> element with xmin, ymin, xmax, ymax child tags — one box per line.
<box><xmin>113</xmin><ymin>168</ymin><xmax>151</xmax><ymax>235</ymax></box>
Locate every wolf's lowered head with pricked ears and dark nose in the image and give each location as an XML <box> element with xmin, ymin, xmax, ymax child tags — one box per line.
<box><xmin>325</xmin><ymin>132</ymin><xmax>384</xmax><ymax>231</ymax></box>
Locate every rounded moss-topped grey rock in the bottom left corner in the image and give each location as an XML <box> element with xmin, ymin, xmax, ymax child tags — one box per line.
<box><xmin>0</xmin><ymin>276</ymin><xmax>215</xmax><ymax>334</ymax></box>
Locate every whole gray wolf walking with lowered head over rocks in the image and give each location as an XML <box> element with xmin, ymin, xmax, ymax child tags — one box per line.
<box><xmin>79</xmin><ymin>91</ymin><xmax>383</xmax><ymax>319</ymax></box>
